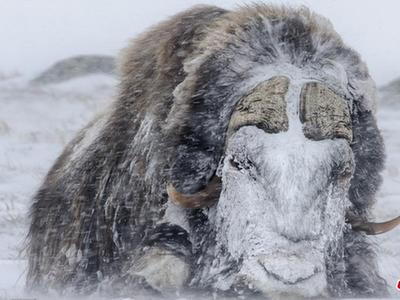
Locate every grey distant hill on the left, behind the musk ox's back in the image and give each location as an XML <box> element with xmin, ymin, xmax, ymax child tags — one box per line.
<box><xmin>31</xmin><ymin>55</ymin><xmax>116</xmax><ymax>85</ymax></box>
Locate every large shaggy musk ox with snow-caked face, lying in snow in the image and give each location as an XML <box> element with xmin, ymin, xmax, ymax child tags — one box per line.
<box><xmin>27</xmin><ymin>4</ymin><xmax>399</xmax><ymax>298</ymax></box>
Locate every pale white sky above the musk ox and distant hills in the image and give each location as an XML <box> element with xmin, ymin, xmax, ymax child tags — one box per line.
<box><xmin>0</xmin><ymin>0</ymin><xmax>400</xmax><ymax>84</ymax></box>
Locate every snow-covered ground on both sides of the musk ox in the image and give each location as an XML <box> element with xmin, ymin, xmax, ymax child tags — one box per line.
<box><xmin>0</xmin><ymin>74</ymin><xmax>400</xmax><ymax>299</ymax></box>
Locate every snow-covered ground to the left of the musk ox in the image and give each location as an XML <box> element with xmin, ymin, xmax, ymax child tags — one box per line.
<box><xmin>0</xmin><ymin>74</ymin><xmax>116</xmax><ymax>299</ymax></box>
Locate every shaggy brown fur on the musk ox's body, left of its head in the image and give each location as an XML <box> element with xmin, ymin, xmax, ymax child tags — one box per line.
<box><xmin>28</xmin><ymin>7</ymin><xmax>228</xmax><ymax>288</ymax></box>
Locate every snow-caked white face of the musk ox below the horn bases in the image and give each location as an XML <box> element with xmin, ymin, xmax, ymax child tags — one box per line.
<box><xmin>209</xmin><ymin>75</ymin><xmax>354</xmax><ymax>297</ymax></box>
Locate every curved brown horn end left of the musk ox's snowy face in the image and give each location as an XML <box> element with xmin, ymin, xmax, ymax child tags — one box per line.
<box><xmin>167</xmin><ymin>176</ymin><xmax>221</xmax><ymax>208</ymax></box>
